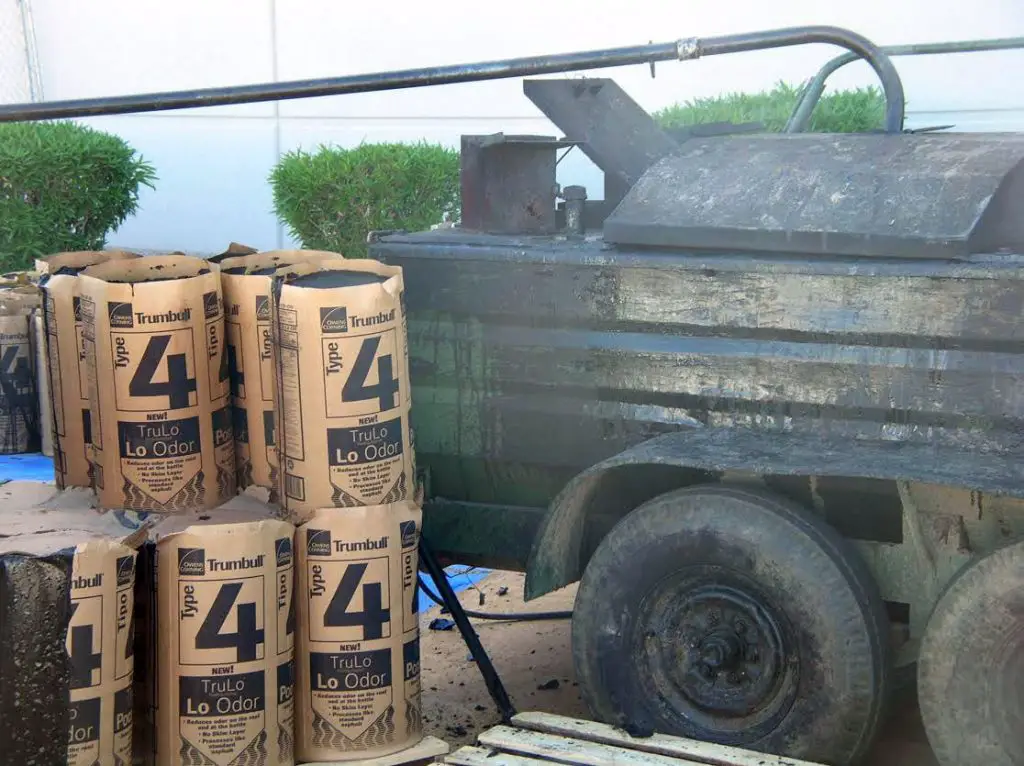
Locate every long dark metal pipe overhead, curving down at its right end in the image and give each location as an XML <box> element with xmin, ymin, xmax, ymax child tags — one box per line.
<box><xmin>0</xmin><ymin>27</ymin><xmax>904</xmax><ymax>132</ymax></box>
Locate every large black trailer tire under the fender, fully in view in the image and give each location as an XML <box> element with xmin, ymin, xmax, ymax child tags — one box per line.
<box><xmin>572</xmin><ymin>485</ymin><xmax>891</xmax><ymax>766</ymax></box>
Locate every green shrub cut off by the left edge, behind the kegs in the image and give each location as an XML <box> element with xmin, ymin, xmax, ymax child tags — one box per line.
<box><xmin>0</xmin><ymin>122</ymin><xmax>156</xmax><ymax>270</ymax></box>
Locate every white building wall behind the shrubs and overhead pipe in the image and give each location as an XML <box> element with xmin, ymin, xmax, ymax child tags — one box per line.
<box><xmin>12</xmin><ymin>0</ymin><xmax>1024</xmax><ymax>252</ymax></box>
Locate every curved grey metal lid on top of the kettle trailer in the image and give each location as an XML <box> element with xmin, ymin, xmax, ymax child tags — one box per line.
<box><xmin>604</xmin><ymin>133</ymin><xmax>1024</xmax><ymax>258</ymax></box>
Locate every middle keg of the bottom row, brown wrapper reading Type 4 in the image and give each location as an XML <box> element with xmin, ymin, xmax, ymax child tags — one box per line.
<box><xmin>156</xmin><ymin>512</ymin><xmax>295</xmax><ymax>766</ymax></box>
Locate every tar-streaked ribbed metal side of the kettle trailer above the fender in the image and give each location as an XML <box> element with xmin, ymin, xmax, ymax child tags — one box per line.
<box><xmin>372</xmin><ymin>230</ymin><xmax>1024</xmax><ymax>507</ymax></box>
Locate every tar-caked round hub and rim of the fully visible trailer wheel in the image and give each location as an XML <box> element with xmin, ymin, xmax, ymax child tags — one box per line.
<box><xmin>641</xmin><ymin>572</ymin><xmax>799</xmax><ymax>741</ymax></box>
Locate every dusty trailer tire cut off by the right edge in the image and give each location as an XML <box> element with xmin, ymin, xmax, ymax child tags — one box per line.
<box><xmin>918</xmin><ymin>540</ymin><xmax>1024</xmax><ymax>766</ymax></box>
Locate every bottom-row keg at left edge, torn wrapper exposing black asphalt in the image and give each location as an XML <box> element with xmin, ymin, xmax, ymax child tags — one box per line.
<box><xmin>0</xmin><ymin>491</ymin><xmax>144</xmax><ymax>766</ymax></box>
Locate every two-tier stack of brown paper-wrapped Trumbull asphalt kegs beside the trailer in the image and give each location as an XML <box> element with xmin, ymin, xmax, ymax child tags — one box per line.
<box><xmin>0</xmin><ymin>246</ymin><xmax>422</xmax><ymax>766</ymax></box>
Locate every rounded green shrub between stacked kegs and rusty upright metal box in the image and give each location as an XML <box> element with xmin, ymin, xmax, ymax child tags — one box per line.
<box><xmin>270</xmin><ymin>142</ymin><xmax>459</xmax><ymax>258</ymax></box>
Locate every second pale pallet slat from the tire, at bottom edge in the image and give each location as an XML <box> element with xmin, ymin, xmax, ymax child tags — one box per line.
<box><xmin>477</xmin><ymin>726</ymin><xmax>702</xmax><ymax>766</ymax></box>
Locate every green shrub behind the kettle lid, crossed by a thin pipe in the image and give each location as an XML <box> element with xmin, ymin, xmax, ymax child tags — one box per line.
<box><xmin>654</xmin><ymin>83</ymin><xmax>886</xmax><ymax>133</ymax></box>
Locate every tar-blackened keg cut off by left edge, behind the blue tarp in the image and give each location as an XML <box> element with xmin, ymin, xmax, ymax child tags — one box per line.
<box><xmin>0</xmin><ymin>283</ymin><xmax>41</xmax><ymax>455</ymax></box>
